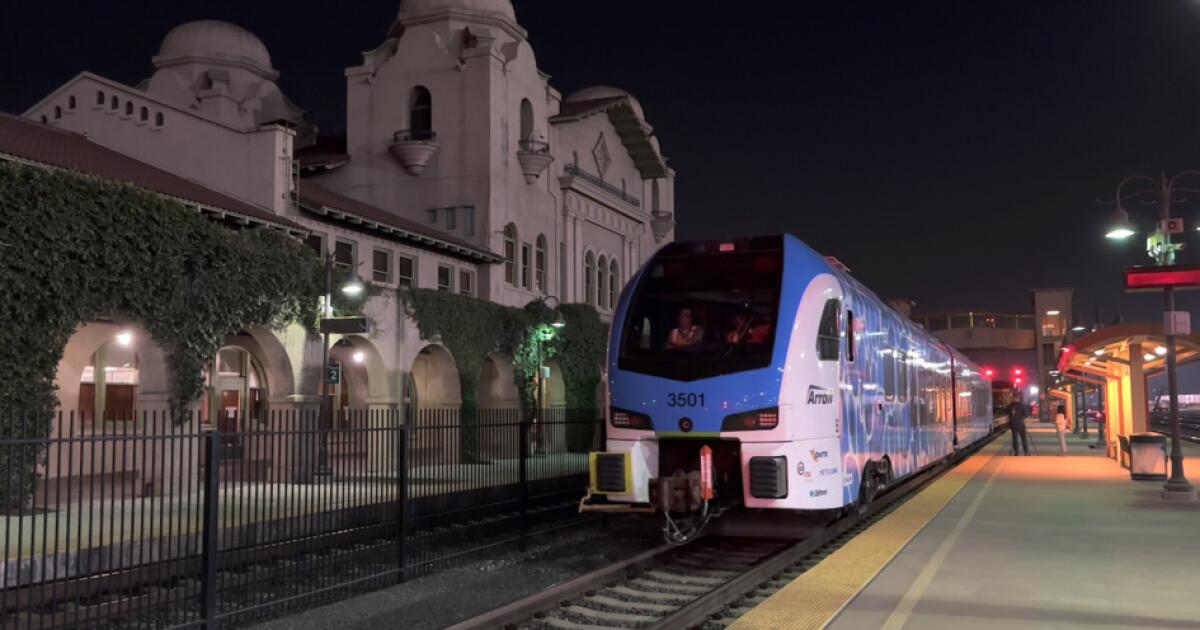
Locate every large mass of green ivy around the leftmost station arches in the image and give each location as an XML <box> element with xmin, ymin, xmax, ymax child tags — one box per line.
<box><xmin>0</xmin><ymin>162</ymin><xmax>324</xmax><ymax>506</ymax></box>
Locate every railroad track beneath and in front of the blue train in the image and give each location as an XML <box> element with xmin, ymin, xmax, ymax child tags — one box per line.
<box><xmin>449</xmin><ymin>433</ymin><xmax>1000</xmax><ymax>630</ymax></box>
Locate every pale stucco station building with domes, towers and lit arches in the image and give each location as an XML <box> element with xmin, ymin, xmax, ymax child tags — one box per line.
<box><xmin>11</xmin><ymin>0</ymin><xmax>674</xmax><ymax>465</ymax></box>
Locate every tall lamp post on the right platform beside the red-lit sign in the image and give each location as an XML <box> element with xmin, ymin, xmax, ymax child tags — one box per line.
<box><xmin>1105</xmin><ymin>170</ymin><xmax>1200</xmax><ymax>500</ymax></box>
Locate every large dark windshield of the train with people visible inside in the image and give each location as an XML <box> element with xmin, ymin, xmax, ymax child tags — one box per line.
<box><xmin>618</xmin><ymin>247</ymin><xmax>784</xmax><ymax>380</ymax></box>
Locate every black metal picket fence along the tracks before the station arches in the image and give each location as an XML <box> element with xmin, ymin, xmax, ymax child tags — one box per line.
<box><xmin>0</xmin><ymin>409</ymin><xmax>604</xmax><ymax>629</ymax></box>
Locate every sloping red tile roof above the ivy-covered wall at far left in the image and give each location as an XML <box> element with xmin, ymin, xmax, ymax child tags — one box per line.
<box><xmin>0</xmin><ymin>112</ymin><xmax>300</xmax><ymax>232</ymax></box>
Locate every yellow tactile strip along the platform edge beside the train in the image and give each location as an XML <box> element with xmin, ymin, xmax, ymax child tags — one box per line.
<box><xmin>730</xmin><ymin>440</ymin><xmax>1002</xmax><ymax>630</ymax></box>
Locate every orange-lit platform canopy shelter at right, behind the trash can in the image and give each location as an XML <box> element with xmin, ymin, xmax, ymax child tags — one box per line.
<box><xmin>1050</xmin><ymin>324</ymin><xmax>1200</xmax><ymax>456</ymax></box>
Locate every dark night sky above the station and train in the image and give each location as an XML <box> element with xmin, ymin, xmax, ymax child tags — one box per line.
<box><xmin>7</xmin><ymin>0</ymin><xmax>1200</xmax><ymax>320</ymax></box>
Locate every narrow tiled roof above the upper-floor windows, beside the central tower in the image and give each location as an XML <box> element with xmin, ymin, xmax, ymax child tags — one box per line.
<box><xmin>300</xmin><ymin>179</ymin><xmax>504</xmax><ymax>263</ymax></box>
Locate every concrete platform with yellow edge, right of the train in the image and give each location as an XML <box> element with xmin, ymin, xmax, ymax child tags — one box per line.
<box><xmin>732</xmin><ymin>428</ymin><xmax>1200</xmax><ymax>630</ymax></box>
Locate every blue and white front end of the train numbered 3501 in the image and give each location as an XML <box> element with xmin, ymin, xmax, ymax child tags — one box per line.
<box><xmin>583</xmin><ymin>236</ymin><xmax>841</xmax><ymax>541</ymax></box>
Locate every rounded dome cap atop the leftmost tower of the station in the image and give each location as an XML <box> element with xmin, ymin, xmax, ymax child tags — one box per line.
<box><xmin>155</xmin><ymin>19</ymin><xmax>271</xmax><ymax>72</ymax></box>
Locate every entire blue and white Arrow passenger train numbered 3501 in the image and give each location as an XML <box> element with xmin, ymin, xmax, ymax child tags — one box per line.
<box><xmin>583</xmin><ymin>235</ymin><xmax>994</xmax><ymax>541</ymax></box>
